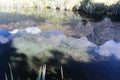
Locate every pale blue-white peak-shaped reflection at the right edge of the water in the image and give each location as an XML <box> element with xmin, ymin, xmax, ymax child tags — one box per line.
<box><xmin>98</xmin><ymin>40</ymin><xmax>120</xmax><ymax>59</ymax></box>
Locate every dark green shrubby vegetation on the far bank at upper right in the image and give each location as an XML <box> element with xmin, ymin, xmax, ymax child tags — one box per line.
<box><xmin>78</xmin><ymin>0</ymin><xmax>120</xmax><ymax>15</ymax></box>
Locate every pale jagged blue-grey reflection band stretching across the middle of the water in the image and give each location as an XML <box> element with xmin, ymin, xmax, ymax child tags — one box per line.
<box><xmin>0</xmin><ymin>27</ymin><xmax>120</xmax><ymax>60</ymax></box>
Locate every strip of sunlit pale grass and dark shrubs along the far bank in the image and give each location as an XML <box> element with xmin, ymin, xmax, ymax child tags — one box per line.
<box><xmin>0</xmin><ymin>0</ymin><xmax>120</xmax><ymax>15</ymax></box>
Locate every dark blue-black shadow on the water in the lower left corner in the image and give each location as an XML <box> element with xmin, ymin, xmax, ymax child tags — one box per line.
<box><xmin>0</xmin><ymin>41</ymin><xmax>36</xmax><ymax>80</ymax></box>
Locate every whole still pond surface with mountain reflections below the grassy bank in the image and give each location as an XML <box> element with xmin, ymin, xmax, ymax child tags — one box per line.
<box><xmin>0</xmin><ymin>9</ymin><xmax>120</xmax><ymax>80</ymax></box>
